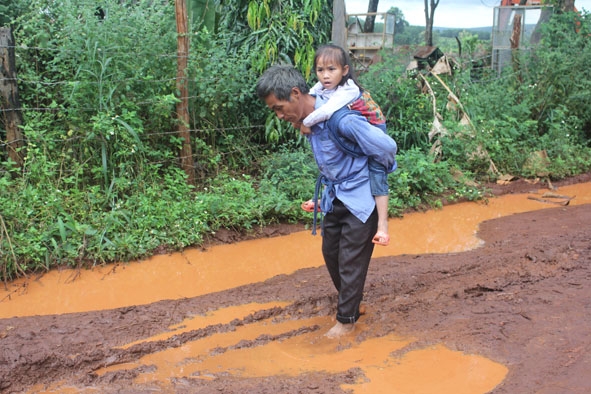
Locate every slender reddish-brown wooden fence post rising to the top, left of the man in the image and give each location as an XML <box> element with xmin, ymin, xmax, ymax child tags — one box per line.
<box><xmin>174</xmin><ymin>0</ymin><xmax>195</xmax><ymax>185</ymax></box>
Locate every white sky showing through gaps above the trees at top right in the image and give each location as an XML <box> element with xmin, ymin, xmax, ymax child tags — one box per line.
<box><xmin>345</xmin><ymin>0</ymin><xmax>591</xmax><ymax>28</ymax></box>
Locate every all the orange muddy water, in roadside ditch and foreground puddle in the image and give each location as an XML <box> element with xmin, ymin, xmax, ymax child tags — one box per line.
<box><xmin>0</xmin><ymin>183</ymin><xmax>591</xmax><ymax>394</ymax></box>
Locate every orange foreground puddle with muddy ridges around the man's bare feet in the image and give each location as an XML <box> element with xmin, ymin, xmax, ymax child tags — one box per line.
<box><xmin>33</xmin><ymin>304</ymin><xmax>508</xmax><ymax>394</ymax></box>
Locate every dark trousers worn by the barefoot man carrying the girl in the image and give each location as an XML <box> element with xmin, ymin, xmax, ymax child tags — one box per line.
<box><xmin>322</xmin><ymin>199</ymin><xmax>378</xmax><ymax>324</ymax></box>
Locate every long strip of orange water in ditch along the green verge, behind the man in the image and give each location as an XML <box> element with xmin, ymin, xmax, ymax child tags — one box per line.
<box><xmin>0</xmin><ymin>183</ymin><xmax>591</xmax><ymax>318</ymax></box>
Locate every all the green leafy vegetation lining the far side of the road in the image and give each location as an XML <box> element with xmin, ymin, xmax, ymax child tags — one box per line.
<box><xmin>0</xmin><ymin>0</ymin><xmax>591</xmax><ymax>280</ymax></box>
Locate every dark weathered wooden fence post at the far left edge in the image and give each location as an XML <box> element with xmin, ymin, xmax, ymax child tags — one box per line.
<box><xmin>0</xmin><ymin>27</ymin><xmax>25</xmax><ymax>167</ymax></box>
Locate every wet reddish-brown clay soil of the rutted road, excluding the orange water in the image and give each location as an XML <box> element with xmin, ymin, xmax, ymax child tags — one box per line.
<box><xmin>0</xmin><ymin>174</ymin><xmax>591</xmax><ymax>394</ymax></box>
